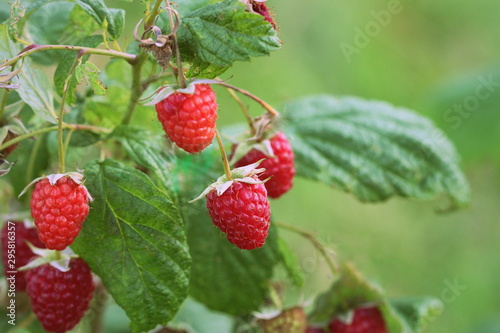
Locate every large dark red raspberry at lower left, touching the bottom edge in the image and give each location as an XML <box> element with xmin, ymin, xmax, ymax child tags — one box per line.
<box><xmin>26</xmin><ymin>258</ymin><xmax>94</xmax><ymax>333</ymax></box>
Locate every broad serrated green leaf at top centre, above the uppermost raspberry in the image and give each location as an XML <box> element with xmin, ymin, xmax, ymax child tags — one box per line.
<box><xmin>178</xmin><ymin>0</ymin><xmax>281</xmax><ymax>67</ymax></box>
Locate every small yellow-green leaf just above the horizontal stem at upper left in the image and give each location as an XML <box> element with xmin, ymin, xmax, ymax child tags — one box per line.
<box><xmin>59</xmin><ymin>6</ymin><xmax>99</xmax><ymax>44</ymax></box>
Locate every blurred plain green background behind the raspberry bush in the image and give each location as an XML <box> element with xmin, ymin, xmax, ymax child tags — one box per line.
<box><xmin>1</xmin><ymin>0</ymin><xmax>500</xmax><ymax>333</ymax></box>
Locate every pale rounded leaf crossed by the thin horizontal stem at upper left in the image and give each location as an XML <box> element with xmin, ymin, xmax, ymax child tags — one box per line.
<box><xmin>27</xmin><ymin>2</ymin><xmax>75</xmax><ymax>66</ymax></box>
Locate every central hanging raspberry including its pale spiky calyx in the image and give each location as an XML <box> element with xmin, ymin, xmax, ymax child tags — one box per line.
<box><xmin>193</xmin><ymin>161</ymin><xmax>271</xmax><ymax>250</ymax></box>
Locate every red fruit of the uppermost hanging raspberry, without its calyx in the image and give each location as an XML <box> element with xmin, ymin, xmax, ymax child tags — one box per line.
<box><xmin>156</xmin><ymin>84</ymin><xmax>217</xmax><ymax>153</ymax></box>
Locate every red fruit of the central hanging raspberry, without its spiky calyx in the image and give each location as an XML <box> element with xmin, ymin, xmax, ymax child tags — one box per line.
<box><xmin>207</xmin><ymin>181</ymin><xmax>271</xmax><ymax>250</ymax></box>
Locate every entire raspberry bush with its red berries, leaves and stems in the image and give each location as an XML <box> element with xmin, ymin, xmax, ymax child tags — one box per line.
<box><xmin>0</xmin><ymin>0</ymin><xmax>469</xmax><ymax>333</ymax></box>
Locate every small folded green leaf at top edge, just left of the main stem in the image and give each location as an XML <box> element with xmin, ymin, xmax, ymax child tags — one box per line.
<box><xmin>75</xmin><ymin>0</ymin><xmax>125</xmax><ymax>40</ymax></box>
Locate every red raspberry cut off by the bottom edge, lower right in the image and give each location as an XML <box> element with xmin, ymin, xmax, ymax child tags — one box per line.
<box><xmin>329</xmin><ymin>307</ymin><xmax>388</xmax><ymax>333</ymax></box>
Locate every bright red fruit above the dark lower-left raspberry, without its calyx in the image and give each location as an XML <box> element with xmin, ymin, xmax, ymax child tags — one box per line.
<box><xmin>31</xmin><ymin>176</ymin><xmax>89</xmax><ymax>251</ymax></box>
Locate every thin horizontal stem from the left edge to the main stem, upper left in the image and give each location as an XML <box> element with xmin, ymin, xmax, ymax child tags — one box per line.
<box><xmin>0</xmin><ymin>44</ymin><xmax>138</xmax><ymax>68</ymax></box>
